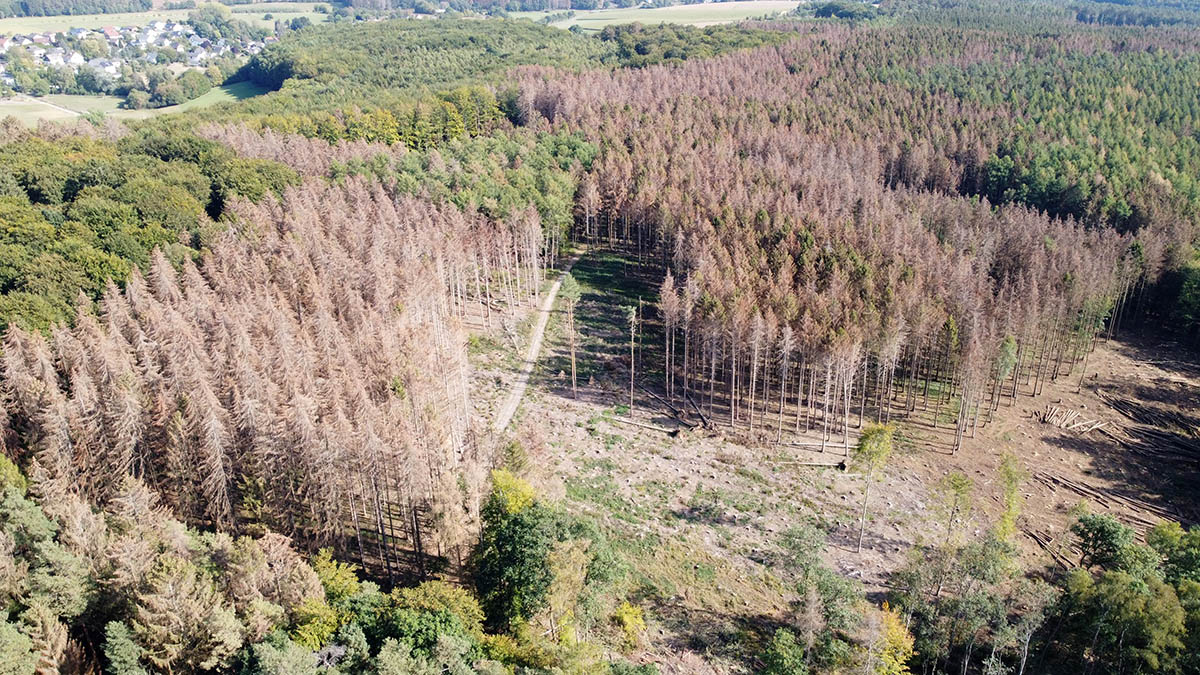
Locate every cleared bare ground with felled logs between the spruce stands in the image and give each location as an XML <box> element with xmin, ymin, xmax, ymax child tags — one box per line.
<box><xmin>475</xmin><ymin>253</ymin><xmax>1200</xmax><ymax>673</ymax></box>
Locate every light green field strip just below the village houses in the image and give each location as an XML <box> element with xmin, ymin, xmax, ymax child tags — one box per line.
<box><xmin>0</xmin><ymin>82</ymin><xmax>265</xmax><ymax>126</ymax></box>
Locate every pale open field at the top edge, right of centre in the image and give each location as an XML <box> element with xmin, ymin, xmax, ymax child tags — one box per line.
<box><xmin>512</xmin><ymin>0</ymin><xmax>800</xmax><ymax>30</ymax></box>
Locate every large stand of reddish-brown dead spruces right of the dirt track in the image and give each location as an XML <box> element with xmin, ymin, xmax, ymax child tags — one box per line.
<box><xmin>516</xmin><ymin>42</ymin><xmax>1123</xmax><ymax>444</ymax></box>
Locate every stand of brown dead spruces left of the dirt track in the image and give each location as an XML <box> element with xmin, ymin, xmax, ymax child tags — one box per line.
<box><xmin>2</xmin><ymin>179</ymin><xmax>541</xmax><ymax>574</ymax></box>
